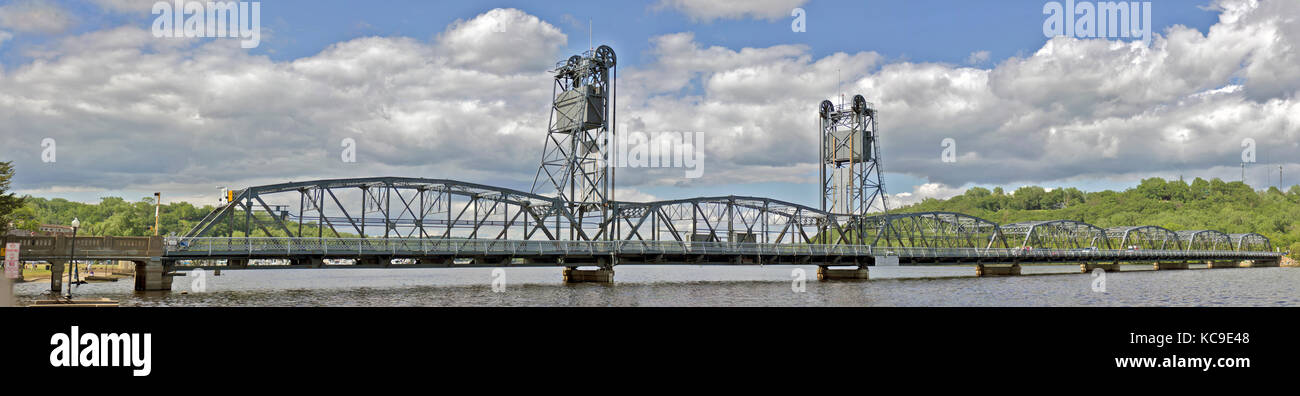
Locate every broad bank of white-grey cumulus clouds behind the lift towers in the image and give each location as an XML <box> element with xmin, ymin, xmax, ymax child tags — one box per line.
<box><xmin>0</xmin><ymin>1</ymin><xmax>1300</xmax><ymax>204</ymax></box>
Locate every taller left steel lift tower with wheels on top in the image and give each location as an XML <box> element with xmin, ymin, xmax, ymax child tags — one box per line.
<box><xmin>532</xmin><ymin>45</ymin><xmax>618</xmax><ymax>239</ymax></box>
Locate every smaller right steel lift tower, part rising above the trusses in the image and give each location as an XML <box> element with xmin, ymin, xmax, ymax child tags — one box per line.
<box><xmin>818</xmin><ymin>95</ymin><xmax>889</xmax><ymax>216</ymax></box>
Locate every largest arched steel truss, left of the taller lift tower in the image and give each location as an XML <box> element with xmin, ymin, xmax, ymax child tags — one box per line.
<box><xmin>186</xmin><ymin>177</ymin><xmax>590</xmax><ymax>240</ymax></box>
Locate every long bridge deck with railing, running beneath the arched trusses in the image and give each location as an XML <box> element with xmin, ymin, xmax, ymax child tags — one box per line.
<box><xmin>164</xmin><ymin>238</ymin><xmax>1281</xmax><ymax>266</ymax></box>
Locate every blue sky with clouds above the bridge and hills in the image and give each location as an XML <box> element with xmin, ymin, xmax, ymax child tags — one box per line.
<box><xmin>0</xmin><ymin>0</ymin><xmax>1300</xmax><ymax>206</ymax></box>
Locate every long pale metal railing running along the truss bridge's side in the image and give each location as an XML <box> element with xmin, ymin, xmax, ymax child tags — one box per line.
<box><xmin>165</xmin><ymin>238</ymin><xmax>1279</xmax><ymax>261</ymax></box>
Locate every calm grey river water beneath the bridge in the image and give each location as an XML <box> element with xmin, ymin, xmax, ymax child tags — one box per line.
<box><xmin>14</xmin><ymin>265</ymin><xmax>1300</xmax><ymax>306</ymax></box>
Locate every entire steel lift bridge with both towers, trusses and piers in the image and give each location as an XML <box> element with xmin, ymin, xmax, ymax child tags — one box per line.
<box><xmin>5</xmin><ymin>45</ymin><xmax>1281</xmax><ymax>290</ymax></box>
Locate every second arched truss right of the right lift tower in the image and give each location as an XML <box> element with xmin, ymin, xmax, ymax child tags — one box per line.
<box><xmin>1001</xmin><ymin>219</ymin><xmax>1113</xmax><ymax>249</ymax></box>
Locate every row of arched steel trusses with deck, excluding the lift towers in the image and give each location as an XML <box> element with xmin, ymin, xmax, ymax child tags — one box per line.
<box><xmin>164</xmin><ymin>178</ymin><xmax>1279</xmax><ymax>267</ymax></box>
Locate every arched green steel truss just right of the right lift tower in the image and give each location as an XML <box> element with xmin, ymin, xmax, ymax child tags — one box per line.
<box><xmin>871</xmin><ymin>212</ymin><xmax>1009</xmax><ymax>249</ymax></box>
